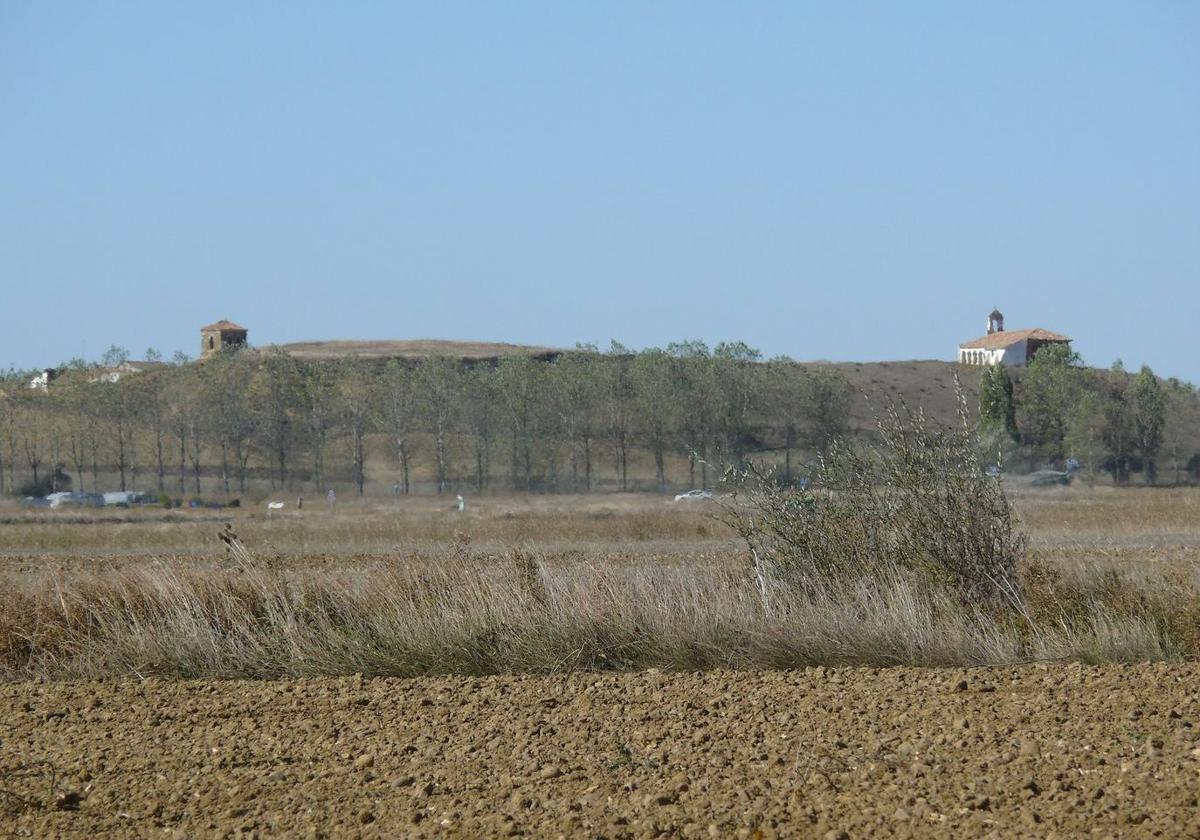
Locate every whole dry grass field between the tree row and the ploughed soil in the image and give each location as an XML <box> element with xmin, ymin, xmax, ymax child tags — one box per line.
<box><xmin>0</xmin><ymin>487</ymin><xmax>1200</xmax><ymax>678</ymax></box>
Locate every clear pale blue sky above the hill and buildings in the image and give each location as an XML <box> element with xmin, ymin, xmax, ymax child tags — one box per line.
<box><xmin>0</xmin><ymin>0</ymin><xmax>1200</xmax><ymax>380</ymax></box>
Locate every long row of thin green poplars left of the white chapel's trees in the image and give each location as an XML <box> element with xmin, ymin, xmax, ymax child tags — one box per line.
<box><xmin>0</xmin><ymin>342</ymin><xmax>853</xmax><ymax>496</ymax></box>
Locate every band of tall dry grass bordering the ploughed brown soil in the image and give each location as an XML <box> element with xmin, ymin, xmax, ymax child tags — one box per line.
<box><xmin>0</xmin><ymin>530</ymin><xmax>1200</xmax><ymax>679</ymax></box>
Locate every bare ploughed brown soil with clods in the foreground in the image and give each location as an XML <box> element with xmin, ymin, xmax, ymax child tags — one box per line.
<box><xmin>0</xmin><ymin>664</ymin><xmax>1200</xmax><ymax>838</ymax></box>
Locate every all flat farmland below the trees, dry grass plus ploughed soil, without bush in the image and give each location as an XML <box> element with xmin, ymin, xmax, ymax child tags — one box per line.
<box><xmin>0</xmin><ymin>487</ymin><xmax>1200</xmax><ymax>838</ymax></box>
